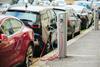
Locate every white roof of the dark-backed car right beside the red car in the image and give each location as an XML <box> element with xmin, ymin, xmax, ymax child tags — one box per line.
<box><xmin>8</xmin><ymin>5</ymin><xmax>51</xmax><ymax>12</ymax></box>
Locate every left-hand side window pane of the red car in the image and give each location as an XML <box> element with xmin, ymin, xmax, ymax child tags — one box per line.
<box><xmin>1</xmin><ymin>19</ymin><xmax>14</xmax><ymax>36</ymax></box>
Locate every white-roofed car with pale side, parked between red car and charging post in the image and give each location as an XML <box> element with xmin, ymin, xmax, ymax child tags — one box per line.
<box><xmin>6</xmin><ymin>6</ymin><xmax>57</xmax><ymax>56</ymax></box>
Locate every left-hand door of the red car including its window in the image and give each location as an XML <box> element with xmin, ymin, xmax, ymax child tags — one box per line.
<box><xmin>1</xmin><ymin>18</ymin><xmax>16</xmax><ymax>64</ymax></box>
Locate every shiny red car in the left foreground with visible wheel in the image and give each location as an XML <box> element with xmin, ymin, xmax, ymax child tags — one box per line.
<box><xmin>0</xmin><ymin>15</ymin><xmax>34</xmax><ymax>67</ymax></box>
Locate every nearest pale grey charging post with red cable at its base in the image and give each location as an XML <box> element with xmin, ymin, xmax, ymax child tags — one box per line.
<box><xmin>57</xmin><ymin>13</ymin><xmax>67</xmax><ymax>59</ymax></box>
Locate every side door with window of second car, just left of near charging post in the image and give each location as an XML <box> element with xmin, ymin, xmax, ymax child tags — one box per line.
<box><xmin>47</xmin><ymin>9</ymin><xmax>57</xmax><ymax>43</ymax></box>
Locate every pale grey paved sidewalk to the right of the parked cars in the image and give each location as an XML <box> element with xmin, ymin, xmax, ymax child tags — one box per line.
<box><xmin>46</xmin><ymin>27</ymin><xmax>100</xmax><ymax>67</ymax></box>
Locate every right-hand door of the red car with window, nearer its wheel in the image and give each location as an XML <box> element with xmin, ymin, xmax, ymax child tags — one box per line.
<box><xmin>10</xmin><ymin>19</ymin><xmax>25</xmax><ymax>54</ymax></box>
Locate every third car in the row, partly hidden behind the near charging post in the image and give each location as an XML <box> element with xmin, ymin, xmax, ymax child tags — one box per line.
<box><xmin>54</xmin><ymin>6</ymin><xmax>81</xmax><ymax>38</ymax></box>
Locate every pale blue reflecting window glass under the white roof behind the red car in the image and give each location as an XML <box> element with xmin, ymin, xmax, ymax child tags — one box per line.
<box><xmin>6</xmin><ymin>10</ymin><xmax>37</xmax><ymax>23</ymax></box>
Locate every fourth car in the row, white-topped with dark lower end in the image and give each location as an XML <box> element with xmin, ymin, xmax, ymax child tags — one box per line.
<box><xmin>67</xmin><ymin>5</ymin><xmax>93</xmax><ymax>30</ymax></box>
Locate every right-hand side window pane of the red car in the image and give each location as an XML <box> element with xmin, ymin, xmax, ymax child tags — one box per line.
<box><xmin>11</xmin><ymin>19</ymin><xmax>22</xmax><ymax>32</ymax></box>
